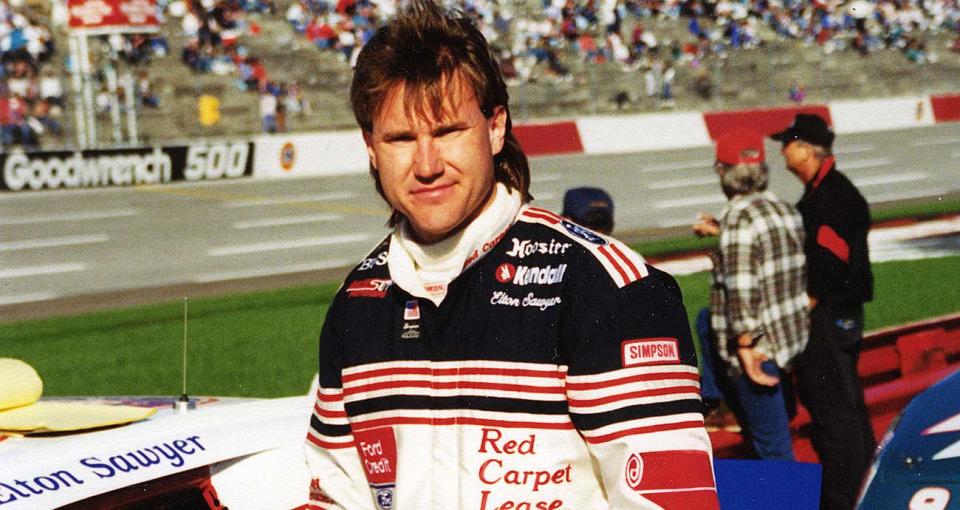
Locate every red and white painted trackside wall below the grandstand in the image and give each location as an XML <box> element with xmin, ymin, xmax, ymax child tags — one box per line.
<box><xmin>254</xmin><ymin>93</ymin><xmax>960</xmax><ymax>178</ymax></box>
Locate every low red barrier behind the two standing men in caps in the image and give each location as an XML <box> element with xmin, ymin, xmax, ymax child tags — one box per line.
<box><xmin>710</xmin><ymin>313</ymin><xmax>960</xmax><ymax>462</ymax></box>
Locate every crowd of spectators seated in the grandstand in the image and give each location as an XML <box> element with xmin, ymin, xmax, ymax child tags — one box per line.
<box><xmin>0</xmin><ymin>0</ymin><xmax>960</xmax><ymax>145</ymax></box>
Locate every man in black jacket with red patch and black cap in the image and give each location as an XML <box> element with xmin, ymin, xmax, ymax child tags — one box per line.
<box><xmin>771</xmin><ymin>113</ymin><xmax>876</xmax><ymax>510</ymax></box>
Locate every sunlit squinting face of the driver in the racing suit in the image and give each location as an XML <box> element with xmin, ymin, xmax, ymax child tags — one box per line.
<box><xmin>363</xmin><ymin>77</ymin><xmax>507</xmax><ymax>243</ymax></box>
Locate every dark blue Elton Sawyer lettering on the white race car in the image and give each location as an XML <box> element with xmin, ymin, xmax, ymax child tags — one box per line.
<box><xmin>0</xmin><ymin>436</ymin><xmax>206</xmax><ymax>506</ymax></box>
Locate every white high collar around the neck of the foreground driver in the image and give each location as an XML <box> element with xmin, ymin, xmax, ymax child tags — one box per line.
<box><xmin>387</xmin><ymin>183</ymin><xmax>522</xmax><ymax>306</ymax></box>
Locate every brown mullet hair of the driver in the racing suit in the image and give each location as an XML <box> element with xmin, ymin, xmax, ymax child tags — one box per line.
<box><xmin>350</xmin><ymin>0</ymin><xmax>533</xmax><ymax>226</ymax></box>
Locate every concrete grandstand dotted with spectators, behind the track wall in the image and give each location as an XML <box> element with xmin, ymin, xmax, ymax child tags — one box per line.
<box><xmin>0</xmin><ymin>0</ymin><xmax>960</xmax><ymax>147</ymax></box>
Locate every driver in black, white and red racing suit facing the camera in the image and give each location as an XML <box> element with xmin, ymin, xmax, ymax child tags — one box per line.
<box><xmin>306</xmin><ymin>0</ymin><xmax>718</xmax><ymax>510</ymax></box>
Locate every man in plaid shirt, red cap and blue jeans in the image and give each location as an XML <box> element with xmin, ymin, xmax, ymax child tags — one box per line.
<box><xmin>694</xmin><ymin>131</ymin><xmax>809</xmax><ymax>460</ymax></box>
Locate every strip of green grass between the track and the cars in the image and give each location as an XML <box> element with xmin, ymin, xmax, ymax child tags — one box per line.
<box><xmin>0</xmin><ymin>256</ymin><xmax>960</xmax><ymax>397</ymax></box>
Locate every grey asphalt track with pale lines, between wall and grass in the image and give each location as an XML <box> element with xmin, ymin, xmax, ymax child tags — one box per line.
<box><xmin>0</xmin><ymin>124</ymin><xmax>960</xmax><ymax>320</ymax></box>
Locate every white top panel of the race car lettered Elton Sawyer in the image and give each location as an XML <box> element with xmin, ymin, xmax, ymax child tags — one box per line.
<box><xmin>0</xmin><ymin>396</ymin><xmax>312</xmax><ymax>509</ymax></box>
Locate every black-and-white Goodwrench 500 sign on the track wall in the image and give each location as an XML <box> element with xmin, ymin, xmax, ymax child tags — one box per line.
<box><xmin>0</xmin><ymin>142</ymin><xmax>253</xmax><ymax>191</ymax></box>
